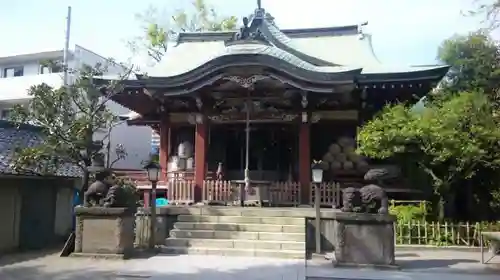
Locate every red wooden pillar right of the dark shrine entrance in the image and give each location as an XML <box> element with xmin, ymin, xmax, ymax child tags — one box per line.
<box><xmin>299</xmin><ymin>122</ymin><xmax>311</xmax><ymax>204</ymax></box>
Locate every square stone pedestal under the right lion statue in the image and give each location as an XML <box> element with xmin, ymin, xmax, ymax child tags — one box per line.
<box><xmin>334</xmin><ymin>213</ymin><xmax>396</xmax><ymax>268</ymax></box>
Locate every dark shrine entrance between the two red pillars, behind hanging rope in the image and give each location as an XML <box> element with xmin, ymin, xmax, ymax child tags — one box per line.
<box><xmin>208</xmin><ymin>122</ymin><xmax>298</xmax><ymax>181</ymax></box>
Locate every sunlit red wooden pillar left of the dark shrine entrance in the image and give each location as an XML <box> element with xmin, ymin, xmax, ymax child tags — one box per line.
<box><xmin>194</xmin><ymin>120</ymin><xmax>208</xmax><ymax>201</ymax></box>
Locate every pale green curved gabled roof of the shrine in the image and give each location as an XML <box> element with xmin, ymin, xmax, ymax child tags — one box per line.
<box><xmin>142</xmin><ymin>5</ymin><xmax>448</xmax><ymax>83</ymax></box>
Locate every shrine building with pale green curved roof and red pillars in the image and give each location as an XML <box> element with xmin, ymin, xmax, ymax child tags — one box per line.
<box><xmin>98</xmin><ymin>3</ymin><xmax>449</xmax><ymax>205</ymax></box>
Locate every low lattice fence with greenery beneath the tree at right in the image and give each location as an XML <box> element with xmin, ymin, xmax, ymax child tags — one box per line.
<box><xmin>394</xmin><ymin>221</ymin><xmax>500</xmax><ymax>247</ymax></box>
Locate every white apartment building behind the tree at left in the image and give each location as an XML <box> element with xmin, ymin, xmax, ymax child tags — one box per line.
<box><xmin>0</xmin><ymin>45</ymin><xmax>152</xmax><ymax>169</ymax></box>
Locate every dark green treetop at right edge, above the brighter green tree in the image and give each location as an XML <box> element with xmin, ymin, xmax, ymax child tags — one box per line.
<box><xmin>438</xmin><ymin>31</ymin><xmax>500</xmax><ymax>97</ymax></box>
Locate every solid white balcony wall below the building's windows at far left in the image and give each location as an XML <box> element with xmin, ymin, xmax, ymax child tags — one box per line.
<box><xmin>0</xmin><ymin>73</ymin><xmax>63</xmax><ymax>101</ymax></box>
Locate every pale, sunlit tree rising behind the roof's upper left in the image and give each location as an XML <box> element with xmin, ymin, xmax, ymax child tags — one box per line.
<box><xmin>129</xmin><ymin>0</ymin><xmax>238</xmax><ymax>62</ymax></box>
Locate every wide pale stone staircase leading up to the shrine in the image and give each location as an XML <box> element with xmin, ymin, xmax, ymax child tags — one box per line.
<box><xmin>162</xmin><ymin>207</ymin><xmax>306</xmax><ymax>259</ymax></box>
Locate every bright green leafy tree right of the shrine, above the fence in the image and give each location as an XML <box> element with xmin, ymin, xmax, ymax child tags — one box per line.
<box><xmin>358</xmin><ymin>92</ymin><xmax>500</xmax><ymax>219</ymax></box>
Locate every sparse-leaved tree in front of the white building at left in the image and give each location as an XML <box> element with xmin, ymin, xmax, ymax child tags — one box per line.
<box><xmin>11</xmin><ymin>62</ymin><xmax>131</xmax><ymax>196</ymax></box>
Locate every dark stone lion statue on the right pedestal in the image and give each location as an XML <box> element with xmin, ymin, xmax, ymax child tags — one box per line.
<box><xmin>341</xmin><ymin>168</ymin><xmax>397</xmax><ymax>214</ymax></box>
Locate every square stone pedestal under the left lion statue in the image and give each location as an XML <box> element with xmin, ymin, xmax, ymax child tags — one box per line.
<box><xmin>74</xmin><ymin>206</ymin><xmax>135</xmax><ymax>258</ymax></box>
